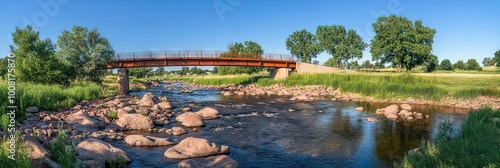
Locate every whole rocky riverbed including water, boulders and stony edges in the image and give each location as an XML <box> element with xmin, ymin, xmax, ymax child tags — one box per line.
<box><xmin>6</xmin><ymin>82</ymin><xmax>472</xmax><ymax>167</ymax></box>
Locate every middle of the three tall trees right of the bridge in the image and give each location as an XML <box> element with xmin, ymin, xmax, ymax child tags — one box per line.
<box><xmin>316</xmin><ymin>25</ymin><xmax>368</xmax><ymax>68</ymax></box>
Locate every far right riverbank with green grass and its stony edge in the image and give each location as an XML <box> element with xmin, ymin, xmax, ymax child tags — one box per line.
<box><xmin>166</xmin><ymin>73</ymin><xmax>500</xmax><ymax>109</ymax></box>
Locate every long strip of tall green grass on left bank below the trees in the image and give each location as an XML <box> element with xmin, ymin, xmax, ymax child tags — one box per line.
<box><xmin>0</xmin><ymin>82</ymin><xmax>102</xmax><ymax>130</ymax></box>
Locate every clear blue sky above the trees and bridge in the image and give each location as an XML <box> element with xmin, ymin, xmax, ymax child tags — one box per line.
<box><xmin>0</xmin><ymin>0</ymin><xmax>500</xmax><ymax>67</ymax></box>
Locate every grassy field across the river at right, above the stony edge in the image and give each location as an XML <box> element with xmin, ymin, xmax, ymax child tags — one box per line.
<box><xmin>163</xmin><ymin>73</ymin><xmax>500</xmax><ymax>100</ymax></box>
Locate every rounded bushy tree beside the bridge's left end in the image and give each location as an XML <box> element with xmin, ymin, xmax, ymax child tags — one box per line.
<box><xmin>57</xmin><ymin>26</ymin><xmax>115</xmax><ymax>82</ymax></box>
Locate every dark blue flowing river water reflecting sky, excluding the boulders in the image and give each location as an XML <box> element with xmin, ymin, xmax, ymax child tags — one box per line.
<box><xmin>108</xmin><ymin>83</ymin><xmax>466</xmax><ymax>167</ymax></box>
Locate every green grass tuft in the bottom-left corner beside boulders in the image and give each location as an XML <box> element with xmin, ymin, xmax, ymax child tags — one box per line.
<box><xmin>0</xmin><ymin>132</ymin><xmax>31</xmax><ymax>168</ymax></box>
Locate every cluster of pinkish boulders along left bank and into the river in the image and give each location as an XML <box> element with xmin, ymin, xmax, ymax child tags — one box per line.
<box><xmin>15</xmin><ymin>90</ymin><xmax>238</xmax><ymax>168</ymax></box>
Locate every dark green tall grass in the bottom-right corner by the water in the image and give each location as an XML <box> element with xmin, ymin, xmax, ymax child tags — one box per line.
<box><xmin>395</xmin><ymin>108</ymin><xmax>500</xmax><ymax>168</ymax></box>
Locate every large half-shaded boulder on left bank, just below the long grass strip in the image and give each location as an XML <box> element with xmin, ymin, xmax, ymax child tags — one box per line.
<box><xmin>66</xmin><ymin>111</ymin><xmax>106</xmax><ymax>132</ymax></box>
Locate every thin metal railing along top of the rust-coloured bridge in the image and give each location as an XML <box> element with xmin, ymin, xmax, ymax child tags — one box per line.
<box><xmin>114</xmin><ymin>51</ymin><xmax>293</xmax><ymax>61</ymax></box>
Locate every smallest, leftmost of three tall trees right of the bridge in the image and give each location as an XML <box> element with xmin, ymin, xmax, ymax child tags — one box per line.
<box><xmin>285</xmin><ymin>29</ymin><xmax>321</xmax><ymax>63</ymax></box>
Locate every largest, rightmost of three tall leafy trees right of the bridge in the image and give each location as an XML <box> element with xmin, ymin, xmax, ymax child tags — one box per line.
<box><xmin>370</xmin><ymin>15</ymin><xmax>436</xmax><ymax>72</ymax></box>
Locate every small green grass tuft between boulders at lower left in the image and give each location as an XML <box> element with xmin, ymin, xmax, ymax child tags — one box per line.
<box><xmin>49</xmin><ymin>129</ymin><xmax>76</xmax><ymax>168</ymax></box>
